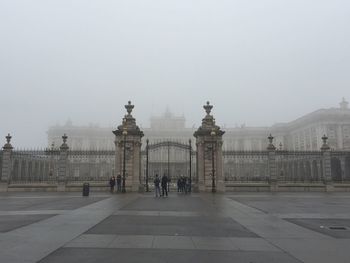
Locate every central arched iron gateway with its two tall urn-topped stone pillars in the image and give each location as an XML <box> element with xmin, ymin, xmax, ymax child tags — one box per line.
<box><xmin>113</xmin><ymin>101</ymin><xmax>225</xmax><ymax>192</ymax></box>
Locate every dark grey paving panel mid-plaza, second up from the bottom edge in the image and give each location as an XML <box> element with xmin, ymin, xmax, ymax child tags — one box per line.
<box><xmin>87</xmin><ymin>215</ymin><xmax>257</xmax><ymax>237</ymax></box>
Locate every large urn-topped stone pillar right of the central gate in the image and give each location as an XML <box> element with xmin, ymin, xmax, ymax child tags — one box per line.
<box><xmin>194</xmin><ymin>101</ymin><xmax>225</xmax><ymax>192</ymax></box>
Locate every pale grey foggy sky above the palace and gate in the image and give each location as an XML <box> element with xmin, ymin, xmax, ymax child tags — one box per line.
<box><xmin>0</xmin><ymin>0</ymin><xmax>350</xmax><ymax>147</ymax></box>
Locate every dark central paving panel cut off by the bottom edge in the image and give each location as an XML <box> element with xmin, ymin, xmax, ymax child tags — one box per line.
<box><xmin>39</xmin><ymin>248</ymin><xmax>301</xmax><ymax>263</ymax></box>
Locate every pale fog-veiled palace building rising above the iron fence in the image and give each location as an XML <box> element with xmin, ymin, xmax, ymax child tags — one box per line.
<box><xmin>47</xmin><ymin>98</ymin><xmax>350</xmax><ymax>151</ymax></box>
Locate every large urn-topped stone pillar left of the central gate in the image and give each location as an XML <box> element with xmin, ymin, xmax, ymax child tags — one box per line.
<box><xmin>113</xmin><ymin>101</ymin><xmax>143</xmax><ymax>192</ymax></box>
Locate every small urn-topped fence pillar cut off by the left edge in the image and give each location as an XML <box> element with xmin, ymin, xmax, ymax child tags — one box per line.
<box><xmin>0</xmin><ymin>134</ymin><xmax>13</xmax><ymax>192</ymax></box>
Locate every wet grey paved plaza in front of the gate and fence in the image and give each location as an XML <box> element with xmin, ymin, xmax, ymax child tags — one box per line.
<box><xmin>0</xmin><ymin>192</ymin><xmax>350</xmax><ymax>263</ymax></box>
